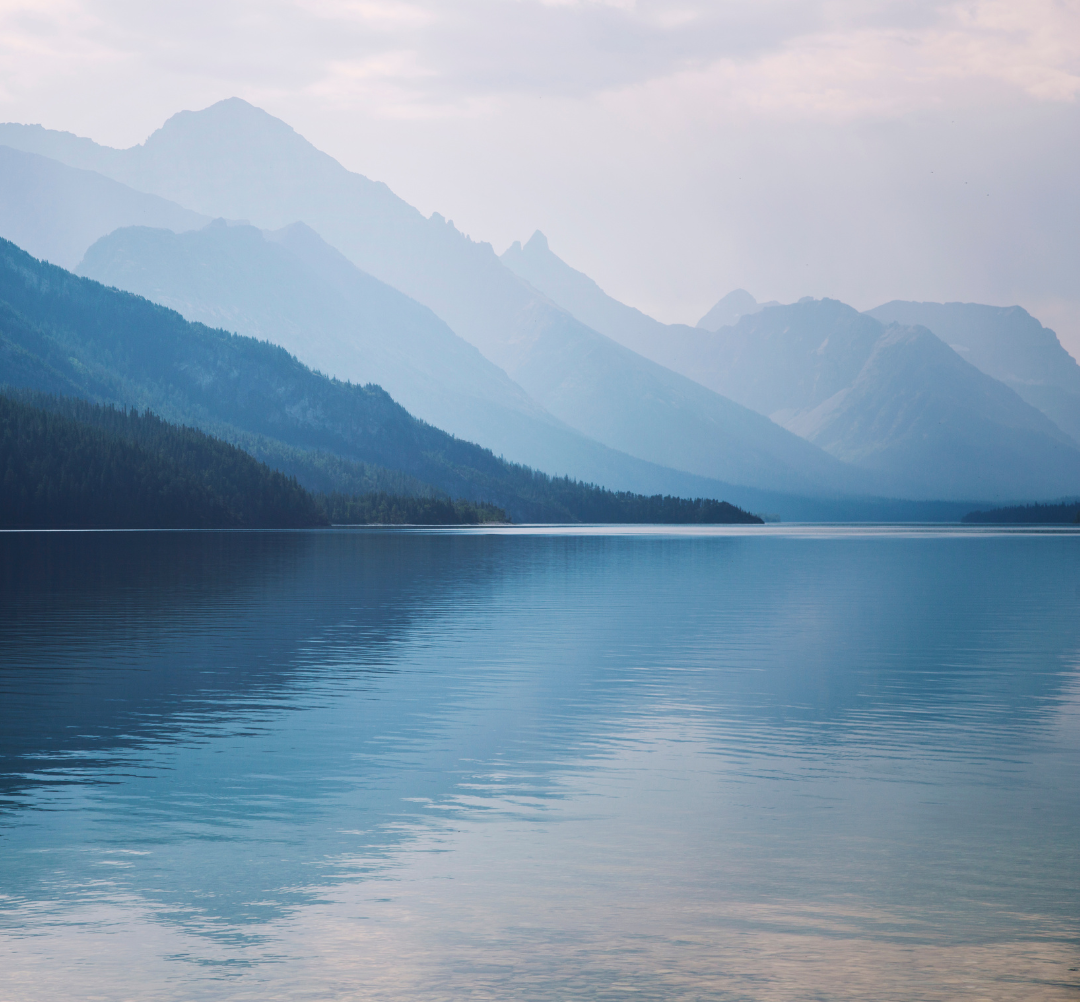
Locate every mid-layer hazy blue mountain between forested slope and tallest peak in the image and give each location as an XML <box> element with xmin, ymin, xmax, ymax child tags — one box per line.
<box><xmin>78</xmin><ymin>220</ymin><xmax>712</xmax><ymax>492</ymax></box>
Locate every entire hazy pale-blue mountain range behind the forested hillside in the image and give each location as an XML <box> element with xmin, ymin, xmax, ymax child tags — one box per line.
<box><xmin>0</xmin><ymin>99</ymin><xmax>1080</xmax><ymax>509</ymax></box>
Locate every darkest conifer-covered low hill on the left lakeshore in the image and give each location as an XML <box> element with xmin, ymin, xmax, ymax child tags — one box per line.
<box><xmin>0</xmin><ymin>395</ymin><xmax>326</xmax><ymax>529</ymax></box>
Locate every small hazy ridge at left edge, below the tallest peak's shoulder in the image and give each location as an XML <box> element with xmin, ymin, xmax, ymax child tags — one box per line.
<box><xmin>0</xmin><ymin>146</ymin><xmax>207</xmax><ymax>268</ymax></box>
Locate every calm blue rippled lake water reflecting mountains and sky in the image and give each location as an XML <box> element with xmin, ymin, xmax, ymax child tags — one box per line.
<box><xmin>0</xmin><ymin>526</ymin><xmax>1080</xmax><ymax>1002</ymax></box>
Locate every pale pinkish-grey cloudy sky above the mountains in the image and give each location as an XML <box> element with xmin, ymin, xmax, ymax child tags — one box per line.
<box><xmin>0</xmin><ymin>0</ymin><xmax>1080</xmax><ymax>355</ymax></box>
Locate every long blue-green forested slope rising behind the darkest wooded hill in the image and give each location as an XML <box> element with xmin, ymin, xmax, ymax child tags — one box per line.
<box><xmin>0</xmin><ymin>241</ymin><xmax>760</xmax><ymax>522</ymax></box>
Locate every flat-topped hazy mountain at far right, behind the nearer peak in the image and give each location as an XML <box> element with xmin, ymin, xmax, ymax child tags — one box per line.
<box><xmin>868</xmin><ymin>300</ymin><xmax>1080</xmax><ymax>442</ymax></box>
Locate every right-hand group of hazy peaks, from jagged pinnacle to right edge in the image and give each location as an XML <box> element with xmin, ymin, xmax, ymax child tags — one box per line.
<box><xmin>503</xmin><ymin>225</ymin><xmax>1080</xmax><ymax>499</ymax></box>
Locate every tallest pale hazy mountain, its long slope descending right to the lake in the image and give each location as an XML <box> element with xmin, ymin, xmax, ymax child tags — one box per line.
<box><xmin>0</xmin><ymin>98</ymin><xmax>877</xmax><ymax>496</ymax></box>
